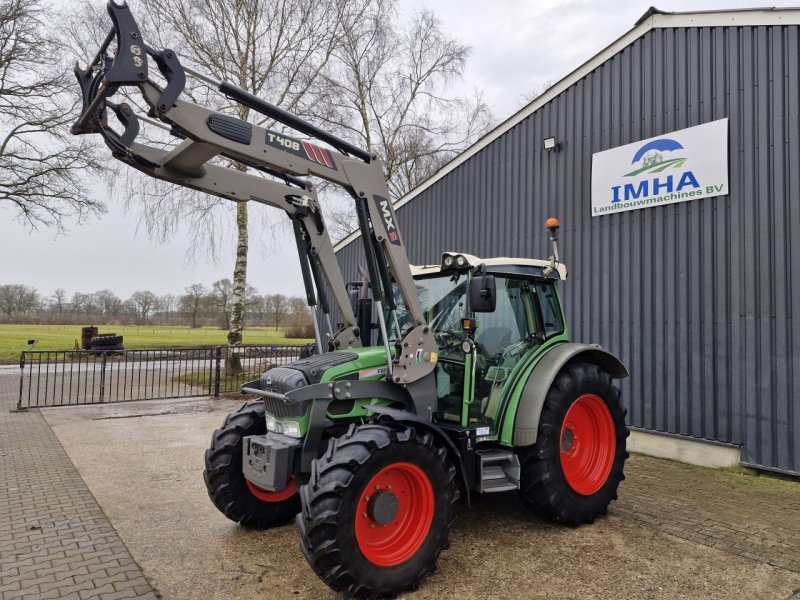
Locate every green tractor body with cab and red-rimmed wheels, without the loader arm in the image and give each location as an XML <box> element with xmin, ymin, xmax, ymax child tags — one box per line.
<box><xmin>204</xmin><ymin>227</ymin><xmax>628</xmax><ymax>597</ymax></box>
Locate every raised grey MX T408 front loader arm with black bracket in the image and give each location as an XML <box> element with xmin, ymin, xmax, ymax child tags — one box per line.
<box><xmin>71</xmin><ymin>0</ymin><xmax>438</xmax><ymax>384</ymax></box>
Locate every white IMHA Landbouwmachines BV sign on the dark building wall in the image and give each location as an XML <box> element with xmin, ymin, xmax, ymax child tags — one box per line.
<box><xmin>592</xmin><ymin>119</ymin><xmax>728</xmax><ymax>217</ymax></box>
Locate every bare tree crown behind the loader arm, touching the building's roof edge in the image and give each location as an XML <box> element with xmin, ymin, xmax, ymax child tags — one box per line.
<box><xmin>321</xmin><ymin>0</ymin><xmax>491</xmax><ymax>237</ymax></box>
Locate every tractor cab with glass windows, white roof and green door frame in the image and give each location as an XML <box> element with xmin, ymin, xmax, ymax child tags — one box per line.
<box><xmin>396</xmin><ymin>252</ymin><xmax>567</xmax><ymax>437</ymax></box>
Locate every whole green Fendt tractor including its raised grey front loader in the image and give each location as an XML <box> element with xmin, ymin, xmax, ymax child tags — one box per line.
<box><xmin>72</xmin><ymin>0</ymin><xmax>628</xmax><ymax>598</ymax></box>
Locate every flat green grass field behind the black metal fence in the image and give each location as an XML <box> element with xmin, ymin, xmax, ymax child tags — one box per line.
<box><xmin>0</xmin><ymin>324</ymin><xmax>312</xmax><ymax>363</ymax></box>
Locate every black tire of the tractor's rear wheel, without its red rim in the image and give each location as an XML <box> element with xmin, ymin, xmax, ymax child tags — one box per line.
<box><xmin>517</xmin><ymin>362</ymin><xmax>629</xmax><ymax>526</ymax></box>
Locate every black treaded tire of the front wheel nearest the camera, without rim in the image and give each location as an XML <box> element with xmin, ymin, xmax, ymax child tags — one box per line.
<box><xmin>297</xmin><ymin>423</ymin><xmax>459</xmax><ymax>598</ymax></box>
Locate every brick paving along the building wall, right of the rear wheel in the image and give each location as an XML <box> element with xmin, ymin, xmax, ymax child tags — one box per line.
<box><xmin>611</xmin><ymin>456</ymin><xmax>800</xmax><ymax>573</ymax></box>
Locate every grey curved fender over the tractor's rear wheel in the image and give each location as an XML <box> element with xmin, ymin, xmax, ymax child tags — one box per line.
<box><xmin>506</xmin><ymin>342</ymin><xmax>629</xmax><ymax>446</ymax></box>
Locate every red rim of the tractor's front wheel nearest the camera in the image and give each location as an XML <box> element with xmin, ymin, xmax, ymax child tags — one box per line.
<box><xmin>355</xmin><ymin>462</ymin><xmax>434</xmax><ymax>567</ymax></box>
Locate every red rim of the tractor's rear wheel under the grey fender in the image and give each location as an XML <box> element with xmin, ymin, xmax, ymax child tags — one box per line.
<box><xmin>560</xmin><ymin>394</ymin><xmax>617</xmax><ymax>496</ymax></box>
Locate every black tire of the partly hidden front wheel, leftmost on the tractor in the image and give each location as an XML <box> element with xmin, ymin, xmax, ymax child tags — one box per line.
<box><xmin>203</xmin><ymin>401</ymin><xmax>300</xmax><ymax>529</ymax></box>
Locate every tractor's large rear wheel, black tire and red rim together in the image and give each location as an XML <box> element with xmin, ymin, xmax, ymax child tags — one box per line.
<box><xmin>517</xmin><ymin>363</ymin><xmax>628</xmax><ymax>526</ymax></box>
